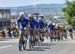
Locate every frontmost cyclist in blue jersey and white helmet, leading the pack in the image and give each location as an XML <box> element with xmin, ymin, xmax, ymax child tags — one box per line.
<box><xmin>16</xmin><ymin>13</ymin><xmax>28</xmax><ymax>51</ymax></box>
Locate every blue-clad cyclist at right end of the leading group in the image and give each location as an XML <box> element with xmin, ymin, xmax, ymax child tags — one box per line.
<box><xmin>39</xmin><ymin>16</ymin><xmax>45</xmax><ymax>44</ymax></box>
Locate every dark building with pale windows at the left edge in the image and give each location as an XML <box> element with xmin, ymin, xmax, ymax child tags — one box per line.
<box><xmin>0</xmin><ymin>9</ymin><xmax>11</xmax><ymax>29</ymax></box>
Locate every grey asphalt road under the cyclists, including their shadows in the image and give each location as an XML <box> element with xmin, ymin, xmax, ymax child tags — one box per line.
<box><xmin>0</xmin><ymin>40</ymin><xmax>75</xmax><ymax>54</ymax></box>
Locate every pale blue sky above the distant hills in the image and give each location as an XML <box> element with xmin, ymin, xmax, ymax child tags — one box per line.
<box><xmin>0</xmin><ymin>0</ymin><xmax>72</xmax><ymax>7</ymax></box>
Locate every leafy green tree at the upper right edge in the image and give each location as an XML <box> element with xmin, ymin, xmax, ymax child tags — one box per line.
<box><xmin>63</xmin><ymin>0</ymin><xmax>75</xmax><ymax>25</ymax></box>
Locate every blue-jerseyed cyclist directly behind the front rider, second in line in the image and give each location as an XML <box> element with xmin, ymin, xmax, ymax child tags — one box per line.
<box><xmin>29</xmin><ymin>16</ymin><xmax>36</xmax><ymax>48</ymax></box>
